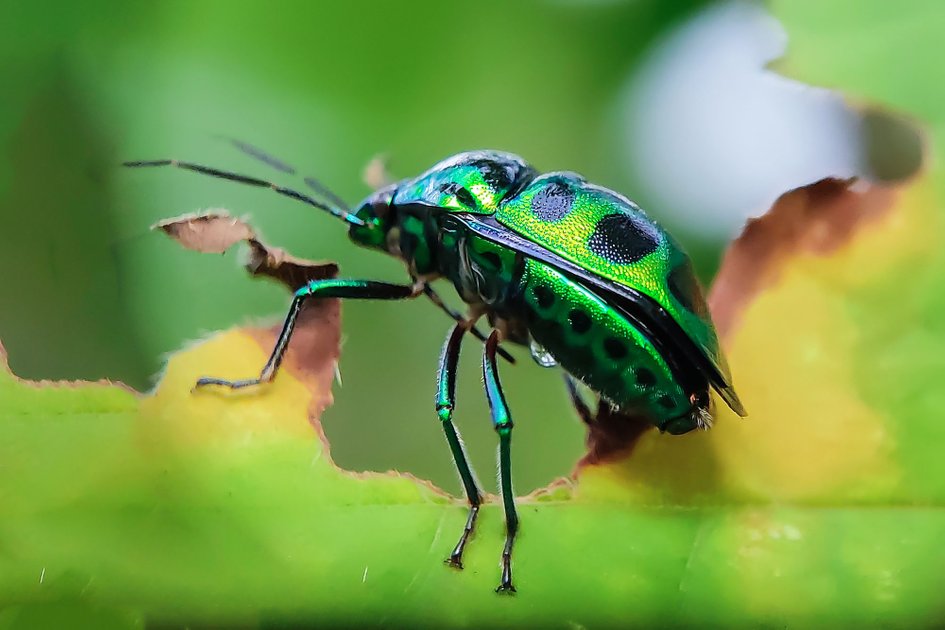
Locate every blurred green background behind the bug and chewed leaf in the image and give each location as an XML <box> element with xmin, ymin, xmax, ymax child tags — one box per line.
<box><xmin>0</xmin><ymin>0</ymin><xmax>876</xmax><ymax>493</ymax></box>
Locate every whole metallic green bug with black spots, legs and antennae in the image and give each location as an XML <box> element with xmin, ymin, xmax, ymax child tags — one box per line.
<box><xmin>125</xmin><ymin>143</ymin><xmax>746</xmax><ymax>593</ymax></box>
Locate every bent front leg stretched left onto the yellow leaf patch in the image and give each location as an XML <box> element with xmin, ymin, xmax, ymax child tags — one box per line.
<box><xmin>194</xmin><ymin>278</ymin><xmax>420</xmax><ymax>389</ymax></box>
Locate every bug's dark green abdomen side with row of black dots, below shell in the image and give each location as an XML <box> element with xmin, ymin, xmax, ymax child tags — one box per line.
<box><xmin>515</xmin><ymin>259</ymin><xmax>692</xmax><ymax>425</ymax></box>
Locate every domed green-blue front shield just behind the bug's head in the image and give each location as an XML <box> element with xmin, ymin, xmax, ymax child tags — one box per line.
<box><xmin>392</xmin><ymin>151</ymin><xmax>536</xmax><ymax>214</ymax></box>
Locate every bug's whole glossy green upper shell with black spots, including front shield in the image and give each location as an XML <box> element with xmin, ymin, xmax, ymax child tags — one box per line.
<box><xmin>391</xmin><ymin>151</ymin><xmax>744</xmax><ymax>415</ymax></box>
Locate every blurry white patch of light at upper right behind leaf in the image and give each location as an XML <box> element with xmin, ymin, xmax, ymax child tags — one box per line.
<box><xmin>624</xmin><ymin>2</ymin><xmax>861</xmax><ymax>238</ymax></box>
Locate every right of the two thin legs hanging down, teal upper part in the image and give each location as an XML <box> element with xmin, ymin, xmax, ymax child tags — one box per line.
<box><xmin>482</xmin><ymin>330</ymin><xmax>518</xmax><ymax>594</ymax></box>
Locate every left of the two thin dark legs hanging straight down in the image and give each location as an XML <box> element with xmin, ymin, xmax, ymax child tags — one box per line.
<box><xmin>436</xmin><ymin>322</ymin><xmax>482</xmax><ymax>569</ymax></box>
